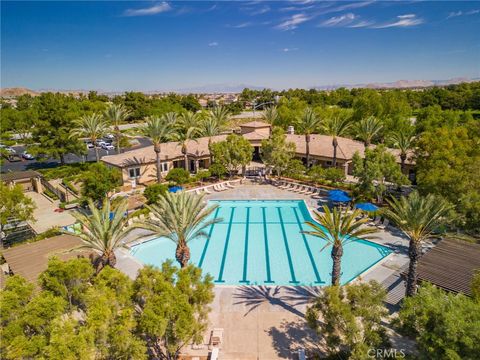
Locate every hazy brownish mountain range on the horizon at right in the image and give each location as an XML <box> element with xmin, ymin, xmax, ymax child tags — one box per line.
<box><xmin>314</xmin><ymin>77</ymin><xmax>479</xmax><ymax>90</ymax></box>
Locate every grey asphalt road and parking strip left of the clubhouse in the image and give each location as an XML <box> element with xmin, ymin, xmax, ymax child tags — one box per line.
<box><xmin>1</xmin><ymin>138</ymin><xmax>152</xmax><ymax>173</ymax></box>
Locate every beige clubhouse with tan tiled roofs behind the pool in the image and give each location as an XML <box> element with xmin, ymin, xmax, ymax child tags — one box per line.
<box><xmin>102</xmin><ymin>121</ymin><xmax>413</xmax><ymax>187</ymax></box>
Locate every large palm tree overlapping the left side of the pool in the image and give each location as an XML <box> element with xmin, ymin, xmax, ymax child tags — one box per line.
<box><xmin>134</xmin><ymin>191</ymin><xmax>222</xmax><ymax>268</ymax></box>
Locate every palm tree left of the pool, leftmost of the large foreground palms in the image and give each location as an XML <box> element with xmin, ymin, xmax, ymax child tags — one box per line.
<box><xmin>68</xmin><ymin>198</ymin><xmax>133</xmax><ymax>273</ymax></box>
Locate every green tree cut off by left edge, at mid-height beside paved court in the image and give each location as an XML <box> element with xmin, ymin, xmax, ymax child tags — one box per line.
<box><xmin>0</xmin><ymin>184</ymin><xmax>36</xmax><ymax>246</ymax></box>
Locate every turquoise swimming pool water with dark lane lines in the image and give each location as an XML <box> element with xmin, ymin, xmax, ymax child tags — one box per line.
<box><xmin>131</xmin><ymin>200</ymin><xmax>390</xmax><ymax>286</ymax></box>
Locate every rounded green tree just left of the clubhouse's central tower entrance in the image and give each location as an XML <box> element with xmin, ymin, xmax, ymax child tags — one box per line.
<box><xmin>210</xmin><ymin>134</ymin><xmax>253</xmax><ymax>176</ymax></box>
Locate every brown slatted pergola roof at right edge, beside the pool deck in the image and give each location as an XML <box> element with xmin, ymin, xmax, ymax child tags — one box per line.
<box><xmin>412</xmin><ymin>239</ymin><xmax>480</xmax><ymax>296</ymax></box>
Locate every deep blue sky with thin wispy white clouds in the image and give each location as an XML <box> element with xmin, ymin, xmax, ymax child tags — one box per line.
<box><xmin>0</xmin><ymin>0</ymin><xmax>480</xmax><ymax>91</ymax></box>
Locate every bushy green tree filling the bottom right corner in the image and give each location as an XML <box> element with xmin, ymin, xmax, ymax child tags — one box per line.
<box><xmin>398</xmin><ymin>284</ymin><xmax>480</xmax><ymax>360</ymax></box>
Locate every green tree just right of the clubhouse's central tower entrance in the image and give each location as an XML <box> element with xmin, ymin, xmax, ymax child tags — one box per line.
<box><xmin>261</xmin><ymin>127</ymin><xmax>296</xmax><ymax>176</ymax></box>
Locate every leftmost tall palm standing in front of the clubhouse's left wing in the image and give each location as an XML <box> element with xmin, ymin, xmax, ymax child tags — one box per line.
<box><xmin>140</xmin><ymin>116</ymin><xmax>174</xmax><ymax>183</ymax></box>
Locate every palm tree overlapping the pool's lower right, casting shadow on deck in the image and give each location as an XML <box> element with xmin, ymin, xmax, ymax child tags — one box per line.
<box><xmin>303</xmin><ymin>205</ymin><xmax>377</xmax><ymax>285</ymax></box>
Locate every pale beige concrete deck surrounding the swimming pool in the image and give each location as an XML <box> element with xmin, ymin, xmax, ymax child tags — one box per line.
<box><xmin>117</xmin><ymin>184</ymin><xmax>408</xmax><ymax>360</ymax></box>
